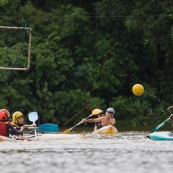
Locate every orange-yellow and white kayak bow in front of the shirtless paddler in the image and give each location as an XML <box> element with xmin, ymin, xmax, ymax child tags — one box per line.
<box><xmin>93</xmin><ymin>126</ymin><xmax>118</xmax><ymax>135</ymax></box>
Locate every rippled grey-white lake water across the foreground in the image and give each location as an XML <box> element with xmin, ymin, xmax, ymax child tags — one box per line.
<box><xmin>0</xmin><ymin>132</ymin><xmax>173</xmax><ymax>173</ymax></box>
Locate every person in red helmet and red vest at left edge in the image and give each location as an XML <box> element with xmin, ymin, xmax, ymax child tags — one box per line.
<box><xmin>0</xmin><ymin>109</ymin><xmax>23</xmax><ymax>137</ymax></box>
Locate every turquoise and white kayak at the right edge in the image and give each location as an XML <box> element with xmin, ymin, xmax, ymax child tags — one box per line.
<box><xmin>147</xmin><ymin>132</ymin><xmax>173</xmax><ymax>141</ymax></box>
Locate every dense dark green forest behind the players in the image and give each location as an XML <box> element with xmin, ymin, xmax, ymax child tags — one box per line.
<box><xmin>0</xmin><ymin>0</ymin><xmax>173</xmax><ymax>129</ymax></box>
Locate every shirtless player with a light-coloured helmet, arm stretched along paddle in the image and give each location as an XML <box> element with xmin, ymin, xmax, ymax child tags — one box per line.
<box><xmin>82</xmin><ymin>108</ymin><xmax>116</xmax><ymax>128</ymax></box>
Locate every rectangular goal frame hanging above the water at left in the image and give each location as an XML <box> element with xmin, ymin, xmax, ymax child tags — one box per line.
<box><xmin>0</xmin><ymin>26</ymin><xmax>32</xmax><ymax>70</ymax></box>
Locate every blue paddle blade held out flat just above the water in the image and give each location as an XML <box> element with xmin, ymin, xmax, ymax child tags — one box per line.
<box><xmin>37</xmin><ymin>123</ymin><xmax>59</xmax><ymax>133</ymax></box>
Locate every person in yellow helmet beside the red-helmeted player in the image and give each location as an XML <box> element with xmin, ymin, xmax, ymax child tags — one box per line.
<box><xmin>10</xmin><ymin>111</ymin><xmax>36</xmax><ymax>140</ymax></box>
